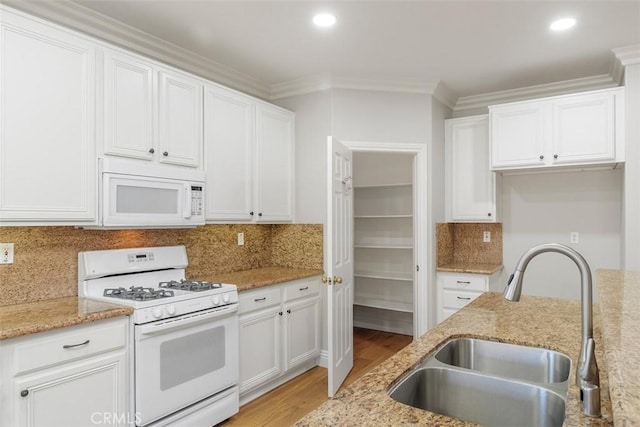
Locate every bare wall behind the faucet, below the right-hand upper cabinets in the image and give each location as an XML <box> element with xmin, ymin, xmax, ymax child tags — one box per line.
<box><xmin>502</xmin><ymin>170</ymin><xmax>623</xmax><ymax>299</ymax></box>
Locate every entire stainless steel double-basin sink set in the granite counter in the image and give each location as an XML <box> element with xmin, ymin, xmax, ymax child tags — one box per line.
<box><xmin>388</xmin><ymin>338</ymin><xmax>571</xmax><ymax>426</ymax></box>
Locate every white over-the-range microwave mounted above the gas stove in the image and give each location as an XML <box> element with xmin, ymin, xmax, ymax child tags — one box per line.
<box><xmin>92</xmin><ymin>158</ymin><xmax>205</xmax><ymax>229</ymax></box>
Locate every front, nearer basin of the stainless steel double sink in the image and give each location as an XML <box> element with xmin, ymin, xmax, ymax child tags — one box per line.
<box><xmin>389</xmin><ymin>368</ymin><xmax>565</xmax><ymax>426</ymax></box>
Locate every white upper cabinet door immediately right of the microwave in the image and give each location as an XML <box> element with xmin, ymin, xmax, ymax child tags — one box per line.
<box><xmin>204</xmin><ymin>86</ymin><xmax>255</xmax><ymax>221</ymax></box>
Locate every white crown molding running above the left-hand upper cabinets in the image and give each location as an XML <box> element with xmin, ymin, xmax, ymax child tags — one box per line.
<box><xmin>2</xmin><ymin>0</ymin><xmax>270</xmax><ymax>99</ymax></box>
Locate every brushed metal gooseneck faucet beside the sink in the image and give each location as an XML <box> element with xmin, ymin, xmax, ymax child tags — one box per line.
<box><xmin>503</xmin><ymin>243</ymin><xmax>600</xmax><ymax>417</ymax></box>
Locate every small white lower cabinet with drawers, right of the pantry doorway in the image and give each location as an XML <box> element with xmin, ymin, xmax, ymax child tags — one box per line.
<box><xmin>437</xmin><ymin>271</ymin><xmax>500</xmax><ymax>323</ymax></box>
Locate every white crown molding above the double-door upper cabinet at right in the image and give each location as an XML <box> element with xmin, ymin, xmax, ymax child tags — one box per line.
<box><xmin>453</xmin><ymin>74</ymin><xmax>618</xmax><ymax>113</ymax></box>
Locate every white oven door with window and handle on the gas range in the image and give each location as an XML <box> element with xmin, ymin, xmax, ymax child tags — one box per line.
<box><xmin>134</xmin><ymin>311</ymin><xmax>239</xmax><ymax>425</ymax></box>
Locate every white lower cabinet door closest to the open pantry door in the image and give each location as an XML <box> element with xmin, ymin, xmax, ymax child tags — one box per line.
<box><xmin>284</xmin><ymin>297</ymin><xmax>320</xmax><ymax>370</ymax></box>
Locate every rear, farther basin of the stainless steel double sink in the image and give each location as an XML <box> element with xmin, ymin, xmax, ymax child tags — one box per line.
<box><xmin>435</xmin><ymin>338</ymin><xmax>571</xmax><ymax>383</ymax></box>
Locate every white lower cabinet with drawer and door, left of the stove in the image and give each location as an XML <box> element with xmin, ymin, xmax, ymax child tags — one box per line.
<box><xmin>0</xmin><ymin>317</ymin><xmax>135</xmax><ymax>427</ymax></box>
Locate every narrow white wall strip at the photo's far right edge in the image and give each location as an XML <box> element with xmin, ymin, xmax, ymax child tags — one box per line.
<box><xmin>623</xmin><ymin>63</ymin><xmax>640</xmax><ymax>270</ymax></box>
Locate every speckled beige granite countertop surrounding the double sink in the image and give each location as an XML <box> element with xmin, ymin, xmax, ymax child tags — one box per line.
<box><xmin>296</xmin><ymin>292</ymin><xmax>616</xmax><ymax>427</ymax></box>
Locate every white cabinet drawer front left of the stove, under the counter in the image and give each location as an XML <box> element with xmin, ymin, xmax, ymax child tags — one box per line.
<box><xmin>14</xmin><ymin>318</ymin><xmax>129</xmax><ymax>374</ymax></box>
